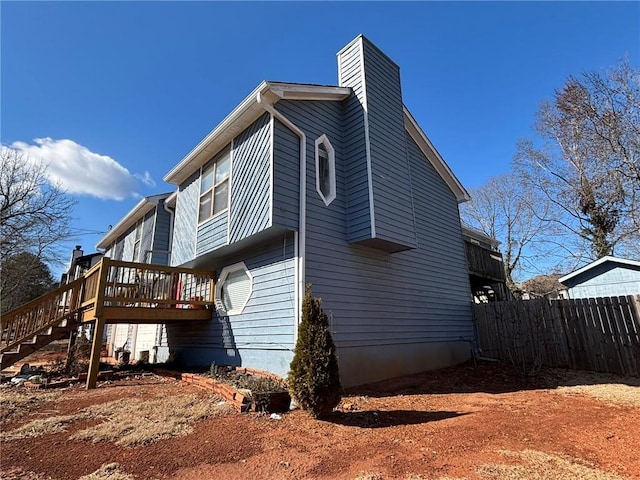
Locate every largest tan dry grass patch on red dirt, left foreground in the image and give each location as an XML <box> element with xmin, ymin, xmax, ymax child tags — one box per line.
<box><xmin>71</xmin><ymin>395</ymin><xmax>232</xmax><ymax>447</ymax></box>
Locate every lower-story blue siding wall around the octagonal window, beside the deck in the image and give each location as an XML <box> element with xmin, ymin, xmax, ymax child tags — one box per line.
<box><xmin>167</xmin><ymin>233</ymin><xmax>295</xmax><ymax>375</ymax></box>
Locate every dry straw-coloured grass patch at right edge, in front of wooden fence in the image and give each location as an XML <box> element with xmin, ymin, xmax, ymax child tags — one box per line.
<box><xmin>553</xmin><ymin>370</ymin><xmax>640</xmax><ymax>407</ymax></box>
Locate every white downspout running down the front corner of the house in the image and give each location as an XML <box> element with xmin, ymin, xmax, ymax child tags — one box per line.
<box><xmin>256</xmin><ymin>92</ymin><xmax>307</xmax><ymax>330</ymax></box>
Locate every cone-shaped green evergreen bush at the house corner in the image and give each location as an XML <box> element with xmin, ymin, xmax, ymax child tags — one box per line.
<box><xmin>287</xmin><ymin>285</ymin><xmax>341</xmax><ymax>418</ymax></box>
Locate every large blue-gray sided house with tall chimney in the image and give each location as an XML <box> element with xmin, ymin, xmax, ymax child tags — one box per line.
<box><xmin>99</xmin><ymin>36</ymin><xmax>473</xmax><ymax>386</ymax></box>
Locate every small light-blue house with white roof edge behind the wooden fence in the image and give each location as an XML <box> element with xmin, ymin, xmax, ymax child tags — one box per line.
<box><xmin>558</xmin><ymin>256</ymin><xmax>640</xmax><ymax>298</ymax></box>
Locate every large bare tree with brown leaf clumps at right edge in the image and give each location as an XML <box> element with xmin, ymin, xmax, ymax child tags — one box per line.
<box><xmin>515</xmin><ymin>60</ymin><xmax>640</xmax><ymax>258</ymax></box>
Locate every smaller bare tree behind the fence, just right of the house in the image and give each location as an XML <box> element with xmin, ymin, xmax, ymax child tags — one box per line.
<box><xmin>461</xmin><ymin>174</ymin><xmax>556</xmax><ymax>295</ymax></box>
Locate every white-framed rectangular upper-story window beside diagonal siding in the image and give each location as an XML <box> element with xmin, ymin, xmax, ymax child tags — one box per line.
<box><xmin>198</xmin><ymin>146</ymin><xmax>231</xmax><ymax>222</ymax></box>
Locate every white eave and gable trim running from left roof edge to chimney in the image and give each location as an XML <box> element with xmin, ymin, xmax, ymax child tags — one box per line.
<box><xmin>164</xmin><ymin>81</ymin><xmax>351</xmax><ymax>185</ymax></box>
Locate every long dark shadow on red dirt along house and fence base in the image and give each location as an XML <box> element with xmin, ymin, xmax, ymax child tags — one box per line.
<box><xmin>345</xmin><ymin>363</ymin><xmax>640</xmax><ymax>397</ymax></box>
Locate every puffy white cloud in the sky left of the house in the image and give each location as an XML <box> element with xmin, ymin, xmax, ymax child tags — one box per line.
<box><xmin>10</xmin><ymin>137</ymin><xmax>148</xmax><ymax>200</ymax></box>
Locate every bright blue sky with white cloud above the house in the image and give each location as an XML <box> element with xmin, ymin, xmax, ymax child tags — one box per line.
<box><xmin>0</xmin><ymin>1</ymin><xmax>640</xmax><ymax>271</ymax></box>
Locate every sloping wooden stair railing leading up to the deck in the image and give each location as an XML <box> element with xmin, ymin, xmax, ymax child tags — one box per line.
<box><xmin>0</xmin><ymin>278</ymin><xmax>84</xmax><ymax>353</ymax></box>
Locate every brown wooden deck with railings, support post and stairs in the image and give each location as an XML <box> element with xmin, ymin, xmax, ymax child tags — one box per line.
<box><xmin>0</xmin><ymin>258</ymin><xmax>215</xmax><ymax>388</ymax></box>
